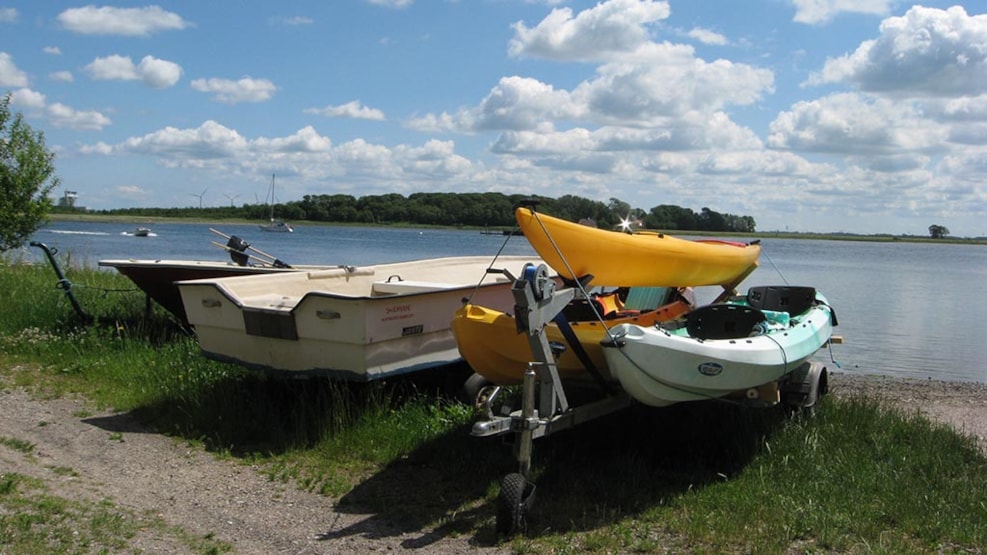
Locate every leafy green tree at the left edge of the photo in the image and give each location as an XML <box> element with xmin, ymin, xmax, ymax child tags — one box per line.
<box><xmin>0</xmin><ymin>93</ymin><xmax>59</xmax><ymax>252</ymax></box>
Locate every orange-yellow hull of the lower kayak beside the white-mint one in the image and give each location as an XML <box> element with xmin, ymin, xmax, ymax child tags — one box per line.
<box><xmin>451</xmin><ymin>288</ymin><xmax>693</xmax><ymax>385</ymax></box>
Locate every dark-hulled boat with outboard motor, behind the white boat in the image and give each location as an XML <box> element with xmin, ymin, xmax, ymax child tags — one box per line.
<box><xmin>99</xmin><ymin>228</ymin><xmax>318</xmax><ymax>324</ymax></box>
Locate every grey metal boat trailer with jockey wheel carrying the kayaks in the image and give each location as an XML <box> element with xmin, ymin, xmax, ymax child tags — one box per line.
<box><xmin>471</xmin><ymin>264</ymin><xmax>842</xmax><ymax>535</ymax></box>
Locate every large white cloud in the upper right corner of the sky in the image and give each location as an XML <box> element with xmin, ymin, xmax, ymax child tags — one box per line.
<box><xmin>808</xmin><ymin>6</ymin><xmax>987</xmax><ymax>97</ymax></box>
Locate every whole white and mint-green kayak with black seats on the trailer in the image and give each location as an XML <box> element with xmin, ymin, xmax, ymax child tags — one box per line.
<box><xmin>603</xmin><ymin>286</ymin><xmax>836</xmax><ymax>406</ymax></box>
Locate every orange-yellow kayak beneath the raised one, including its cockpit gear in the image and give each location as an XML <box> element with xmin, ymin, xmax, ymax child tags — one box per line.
<box><xmin>452</xmin><ymin>287</ymin><xmax>692</xmax><ymax>385</ymax></box>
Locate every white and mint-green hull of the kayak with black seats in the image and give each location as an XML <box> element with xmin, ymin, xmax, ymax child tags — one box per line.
<box><xmin>604</xmin><ymin>295</ymin><xmax>833</xmax><ymax>406</ymax></box>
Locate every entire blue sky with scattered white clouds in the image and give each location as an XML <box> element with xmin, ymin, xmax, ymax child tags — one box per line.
<box><xmin>0</xmin><ymin>0</ymin><xmax>987</xmax><ymax>236</ymax></box>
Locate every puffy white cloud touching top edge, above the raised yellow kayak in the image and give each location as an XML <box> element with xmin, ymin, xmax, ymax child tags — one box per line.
<box><xmin>508</xmin><ymin>0</ymin><xmax>671</xmax><ymax>60</ymax></box>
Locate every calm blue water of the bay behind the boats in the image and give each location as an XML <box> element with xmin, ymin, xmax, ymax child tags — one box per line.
<box><xmin>17</xmin><ymin>222</ymin><xmax>987</xmax><ymax>382</ymax></box>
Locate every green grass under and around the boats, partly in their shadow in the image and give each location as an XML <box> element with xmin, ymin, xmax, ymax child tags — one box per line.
<box><xmin>0</xmin><ymin>258</ymin><xmax>987</xmax><ymax>553</ymax></box>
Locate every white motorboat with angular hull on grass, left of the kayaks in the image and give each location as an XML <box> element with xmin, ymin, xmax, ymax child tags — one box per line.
<box><xmin>177</xmin><ymin>256</ymin><xmax>540</xmax><ymax>381</ymax></box>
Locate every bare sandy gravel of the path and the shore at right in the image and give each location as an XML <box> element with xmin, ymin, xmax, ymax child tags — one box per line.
<box><xmin>0</xmin><ymin>374</ymin><xmax>987</xmax><ymax>554</ymax></box>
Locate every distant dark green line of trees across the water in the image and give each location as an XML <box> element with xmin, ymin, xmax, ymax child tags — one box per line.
<box><xmin>53</xmin><ymin>193</ymin><xmax>755</xmax><ymax>232</ymax></box>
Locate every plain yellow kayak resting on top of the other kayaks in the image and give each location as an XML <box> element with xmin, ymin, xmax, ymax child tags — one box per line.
<box><xmin>514</xmin><ymin>207</ymin><xmax>761</xmax><ymax>287</ymax></box>
